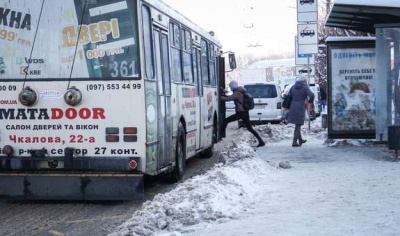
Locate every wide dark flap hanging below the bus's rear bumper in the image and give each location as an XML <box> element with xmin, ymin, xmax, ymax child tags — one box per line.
<box><xmin>0</xmin><ymin>172</ymin><xmax>144</xmax><ymax>201</ymax></box>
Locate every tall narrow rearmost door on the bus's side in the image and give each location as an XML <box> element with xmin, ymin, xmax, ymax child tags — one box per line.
<box><xmin>154</xmin><ymin>26</ymin><xmax>174</xmax><ymax>169</ymax></box>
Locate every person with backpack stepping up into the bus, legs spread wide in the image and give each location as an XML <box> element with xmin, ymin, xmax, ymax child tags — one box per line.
<box><xmin>221</xmin><ymin>80</ymin><xmax>265</xmax><ymax>147</ymax></box>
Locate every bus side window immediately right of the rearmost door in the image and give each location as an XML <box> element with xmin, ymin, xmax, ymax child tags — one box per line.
<box><xmin>169</xmin><ymin>23</ymin><xmax>182</xmax><ymax>82</ymax></box>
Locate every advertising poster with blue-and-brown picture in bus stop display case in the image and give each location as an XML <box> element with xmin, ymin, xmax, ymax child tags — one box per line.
<box><xmin>328</xmin><ymin>44</ymin><xmax>377</xmax><ymax>139</ymax></box>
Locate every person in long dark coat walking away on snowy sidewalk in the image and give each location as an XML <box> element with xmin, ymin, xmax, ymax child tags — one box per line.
<box><xmin>288</xmin><ymin>76</ymin><xmax>314</xmax><ymax>147</ymax></box>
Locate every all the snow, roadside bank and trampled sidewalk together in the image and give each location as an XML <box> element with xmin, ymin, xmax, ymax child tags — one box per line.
<box><xmin>111</xmin><ymin>118</ymin><xmax>400</xmax><ymax>236</ymax></box>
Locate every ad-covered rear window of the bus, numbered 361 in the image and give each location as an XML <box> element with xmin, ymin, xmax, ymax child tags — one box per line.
<box><xmin>0</xmin><ymin>0</ymin><xmax>140</xmax><ymax>80</ymax></box>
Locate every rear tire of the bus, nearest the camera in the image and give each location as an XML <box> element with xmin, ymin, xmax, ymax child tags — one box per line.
<box><xmin>169</xmin><ymin>123</ymin><xmax>186</xmax><ymax>183</ymax></box>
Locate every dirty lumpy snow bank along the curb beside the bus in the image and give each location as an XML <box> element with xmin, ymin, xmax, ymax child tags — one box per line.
<box><xmin>111</xmin><ymin>143</ymin><xmax>277</xmax><ymax>236</ymax></box>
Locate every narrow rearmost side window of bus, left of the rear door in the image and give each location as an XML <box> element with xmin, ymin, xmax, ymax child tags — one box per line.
<box><xmin>142</xmin><ymin>6</ymin><xmax>154</xmax><ymax>79</ymax></box>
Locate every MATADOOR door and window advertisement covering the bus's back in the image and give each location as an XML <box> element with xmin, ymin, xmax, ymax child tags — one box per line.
<box><xmin>0</xmin><ymin>0</ymin><xmax>145</xmax><ymax>157</ymax></box>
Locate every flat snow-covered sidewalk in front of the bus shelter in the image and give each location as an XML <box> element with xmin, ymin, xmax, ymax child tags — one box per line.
<box><xmin>184</xmin><ymin>127</ymin><xmax>400</xmax><ymax>236</ymax></box>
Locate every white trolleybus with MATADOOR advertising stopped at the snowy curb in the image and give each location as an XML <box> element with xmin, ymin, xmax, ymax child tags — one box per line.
<box><xmin>0</xmin><ymin>0</ymin><xmax>235</xmax><ymax>200</ymax></box>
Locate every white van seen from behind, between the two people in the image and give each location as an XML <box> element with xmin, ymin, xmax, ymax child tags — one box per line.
<box><xmin>243</xmin><ymin>82</ymin><xmax>283</xmax><ymax>124</ymax></box>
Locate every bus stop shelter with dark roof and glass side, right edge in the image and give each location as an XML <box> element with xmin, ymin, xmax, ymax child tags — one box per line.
<box><xmin>325</xmin><ymin>0</ymin><xmax>400</xmax><ymax>146</ymax></box>
